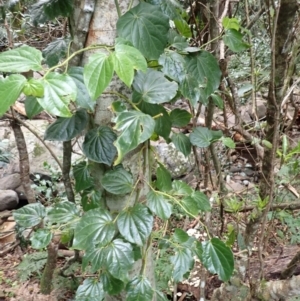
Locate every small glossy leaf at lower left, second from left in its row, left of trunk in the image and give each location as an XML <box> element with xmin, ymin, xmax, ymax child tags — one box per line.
<box><xmin>47</xmin><ymin>201</ymin><xmax>80</xmax><ymax>224</ymax></box>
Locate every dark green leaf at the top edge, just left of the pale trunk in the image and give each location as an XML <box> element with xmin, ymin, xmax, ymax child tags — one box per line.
<box><xmin>44</xmin><ymin>0</ymin><xmax>74</xmax><ymax>19</ymax></box>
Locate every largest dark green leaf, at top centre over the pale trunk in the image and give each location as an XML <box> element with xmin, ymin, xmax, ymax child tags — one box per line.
<box><xmin>117</xmin><ymin>2</ymin><xmax>169</xmax><ymax>60</ymax></box>
